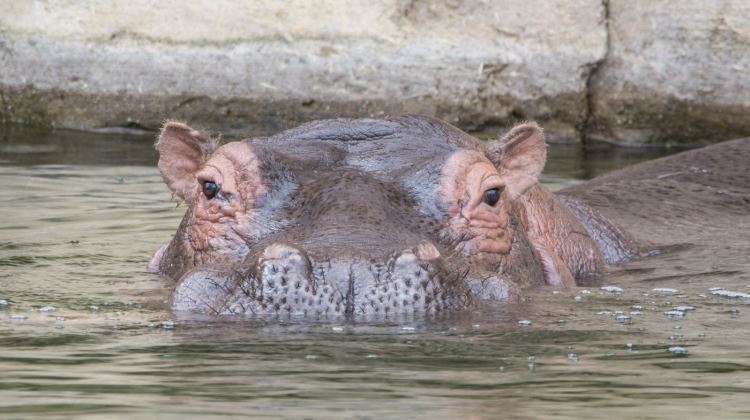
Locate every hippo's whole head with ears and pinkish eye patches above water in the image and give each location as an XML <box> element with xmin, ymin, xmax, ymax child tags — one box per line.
<box><xmin>149</xmin><ymin>117</ymin><xmax>546</xmax><ymax>316</ymax></box>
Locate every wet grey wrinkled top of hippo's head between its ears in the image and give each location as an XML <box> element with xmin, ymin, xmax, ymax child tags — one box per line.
<box><xmin>251</xmin><ymin>116</ymin><xmax>481</xmax><ymax>183</ymax></box>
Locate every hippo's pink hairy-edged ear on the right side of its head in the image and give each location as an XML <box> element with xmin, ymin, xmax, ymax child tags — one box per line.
<box><xmin>487</xmin><ymin>122</ymin><xmax>547</xmax><ymax>199</ymax></box>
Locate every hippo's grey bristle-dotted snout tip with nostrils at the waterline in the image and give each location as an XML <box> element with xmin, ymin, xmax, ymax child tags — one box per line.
<box><xmin>173</xmin><ymin>241</ymin><xmax>468</xmax><ymax>316</ymax></box>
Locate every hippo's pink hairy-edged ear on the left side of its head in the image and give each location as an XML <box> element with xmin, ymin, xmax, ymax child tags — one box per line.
<box><xmin>154</xmin><ymin>121</ymin><xmax>216</xmax><ymax>201</ymax></box>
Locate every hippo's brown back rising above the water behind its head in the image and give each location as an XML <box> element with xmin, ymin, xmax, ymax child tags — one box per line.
<box><xmin>557</xmin><ymin>139</ymin><xmax>750</xmax><ymax>244</ymax></box>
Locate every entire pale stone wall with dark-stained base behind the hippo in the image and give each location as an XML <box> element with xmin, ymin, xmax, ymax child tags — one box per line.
<box><xmin>0</xmin><ymin>0</ymin><xmax>750</xmax><ymax>144</ymax></box>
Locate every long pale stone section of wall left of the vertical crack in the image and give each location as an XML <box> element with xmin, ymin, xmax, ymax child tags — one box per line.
<box><xmin>0</xmin><ymin>0</ymin><xmax>606</xmax><ymax>138</ymax></box>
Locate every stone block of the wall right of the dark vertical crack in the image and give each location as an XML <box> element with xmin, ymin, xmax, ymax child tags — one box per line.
<box><xmin>587</xmin><ymin>0</ymin><xmax>750</xmax><ymax>145</ymax></box>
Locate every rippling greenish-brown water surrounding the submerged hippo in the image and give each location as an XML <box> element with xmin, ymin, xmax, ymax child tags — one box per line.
<box><xmin>0</xmin><ymin>128</ymin><xmax>750</xmax><ymax>419</ymax></box>
